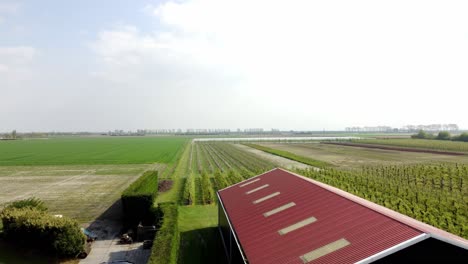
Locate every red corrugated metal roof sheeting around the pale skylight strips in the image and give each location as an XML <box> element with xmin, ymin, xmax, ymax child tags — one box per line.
<box><xmin>219</xmin><ymin>169</ymin><xmax>424</xmax><ymax>264</ymax></box>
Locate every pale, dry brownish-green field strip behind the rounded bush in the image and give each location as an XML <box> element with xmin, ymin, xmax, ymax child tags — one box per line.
<box><xmin>0</xmin><ymin>164</ymin><xmax>165</xmax><ymax>223</ymax></box>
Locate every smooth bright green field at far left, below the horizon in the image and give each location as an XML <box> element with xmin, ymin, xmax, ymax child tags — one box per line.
<box><xmin>0</xmin><ymin>137</ymin><xmax>188</xmax><ymax>166</ymax></box>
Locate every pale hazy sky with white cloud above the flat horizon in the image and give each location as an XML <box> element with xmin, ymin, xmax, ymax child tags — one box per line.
<box><xmin>0</xmin><ymin>0</ymin><xmax>468</xmax><ymax>131</ymax></box>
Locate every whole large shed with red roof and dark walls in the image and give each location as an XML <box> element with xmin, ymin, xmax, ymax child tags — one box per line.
<box><xmin>218</xmin><ymin>169</ymin><xmax>468</xmax><ymax>264</ymax></box>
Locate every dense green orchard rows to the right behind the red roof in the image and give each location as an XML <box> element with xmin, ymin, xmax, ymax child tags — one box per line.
<box><xmin>299</xmin><ymin>164</ymin><xmax>468</xmax><ymax>238</ymax></box>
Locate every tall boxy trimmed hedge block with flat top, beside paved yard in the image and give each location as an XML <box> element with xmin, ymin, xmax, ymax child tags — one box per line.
<box><xmin>121</xmin><ymin>171</ymin><xmax>158</xmax><ymax>226</ymax></box>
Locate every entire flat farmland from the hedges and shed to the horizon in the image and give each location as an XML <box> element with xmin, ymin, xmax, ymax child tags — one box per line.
<box><xmin>0</xmin><ymin>137</ymin><xmax>468</xmax><ymax>263</ymax></box>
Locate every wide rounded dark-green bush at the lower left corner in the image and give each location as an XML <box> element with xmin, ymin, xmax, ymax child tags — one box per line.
<box><xmin>0</xmin><ymin>207</ymin><xmax>86</xmax><ymax>257</ymax></box>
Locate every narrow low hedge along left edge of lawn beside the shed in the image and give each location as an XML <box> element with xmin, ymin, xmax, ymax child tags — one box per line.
<box><xmin>148</xmin><ymin>203</ymin><xmax>180</xmax><ymax>264</ymax></box>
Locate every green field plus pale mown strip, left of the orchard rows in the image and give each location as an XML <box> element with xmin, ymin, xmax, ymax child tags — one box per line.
<box><xmin>0</xmin><ymin>137</ymin><xmax>188</xmax><ymax>223</ymax></box>
